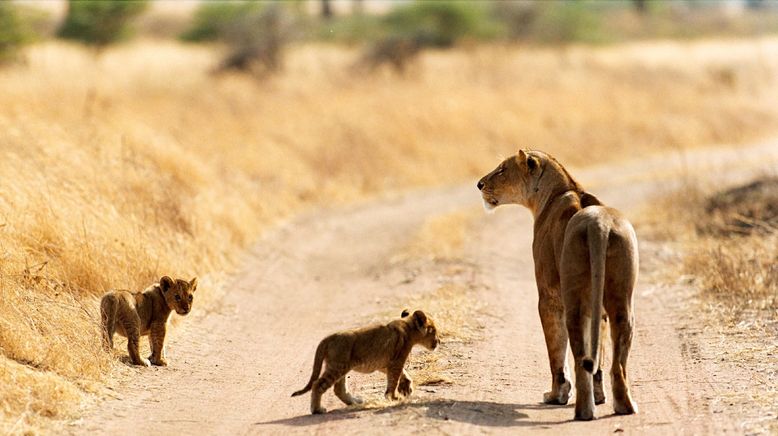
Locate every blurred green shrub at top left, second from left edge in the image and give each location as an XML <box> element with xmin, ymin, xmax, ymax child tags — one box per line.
<box><xmin>57</xmin><ymin>0</ymin><xmax>148</xmax><ymax>46</ymax></box>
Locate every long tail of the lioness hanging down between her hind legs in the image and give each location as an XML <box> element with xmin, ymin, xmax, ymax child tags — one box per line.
<box><xmin>582</xmin><ymin>223</ymin><xmax>610</xmax><ymax>373</ymax></box>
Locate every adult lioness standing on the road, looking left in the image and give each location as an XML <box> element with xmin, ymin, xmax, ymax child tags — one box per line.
<box><xmin>478</xmin><ymin>150</ymin><xmax>638</xmax><ymax>420</ymax></box>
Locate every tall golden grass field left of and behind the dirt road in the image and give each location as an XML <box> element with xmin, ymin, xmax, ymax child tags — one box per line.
<box><xmin>0</xmin><ymin>39</ymin><xmax>778</xmax><ymax>431</ymax></box>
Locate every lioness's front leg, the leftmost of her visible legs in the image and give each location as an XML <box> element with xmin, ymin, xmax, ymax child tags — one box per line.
<box><xmin>538</xmin><ymin>287</ymin><xmax>571</xmax><ymax>404</ymax></box>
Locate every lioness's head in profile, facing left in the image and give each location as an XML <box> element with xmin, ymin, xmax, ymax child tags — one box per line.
<box><xmin>477</xmin><ymin>150</ymin><xmax>544</xmax><ymax>211</ymax></box>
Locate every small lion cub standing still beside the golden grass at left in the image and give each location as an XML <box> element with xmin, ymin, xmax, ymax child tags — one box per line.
<box><xmin>100</xmin><ymin>276</ymin><xmax>197</xmax><ymax>366</ymax></box>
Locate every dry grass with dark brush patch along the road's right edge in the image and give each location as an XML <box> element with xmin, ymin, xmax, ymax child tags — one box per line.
<box><xmin>644</xmin><ymin>177</ymin><xmax>778</xmax><ymax>434</ymax></box>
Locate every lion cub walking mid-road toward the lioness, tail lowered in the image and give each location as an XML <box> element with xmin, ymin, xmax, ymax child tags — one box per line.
<box><xmin>292</xmin><ymin>310</ymin><xmax>439</xmax><ymax>414</ymax></box>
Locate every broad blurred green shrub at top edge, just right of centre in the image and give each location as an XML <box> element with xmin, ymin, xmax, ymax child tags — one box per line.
<box><xmin>384</xmin><ymin>1</ymin><xmax>501</xmax><ymax>47</ymax></box>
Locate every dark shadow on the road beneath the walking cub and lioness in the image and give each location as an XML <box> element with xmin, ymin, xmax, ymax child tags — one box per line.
<box><xmin>254</xmin><ymin>399</ymin><xmax>572</xmax><ymax>427</ymax></box>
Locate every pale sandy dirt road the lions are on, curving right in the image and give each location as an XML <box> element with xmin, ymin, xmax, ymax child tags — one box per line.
<box><xmin>74</xmin><ymin>143</ymin><xmax>776</xmax><ymax>434</ymax></box>
